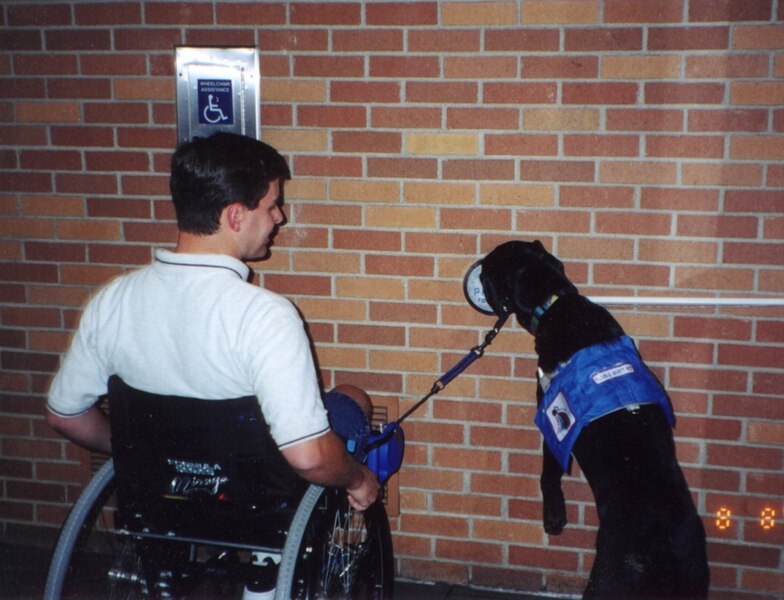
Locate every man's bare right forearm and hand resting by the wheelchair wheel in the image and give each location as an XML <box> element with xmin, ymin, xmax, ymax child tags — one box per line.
<box><xmin>282</xmin><ymin>431</ymin><xmax>380</xmax><ymax>510</ymax></box>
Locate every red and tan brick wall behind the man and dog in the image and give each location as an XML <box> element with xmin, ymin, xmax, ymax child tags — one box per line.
<box><xmin>0</xmin><ymin>0</ymin><xmax>784</xmax><ymax>598</ymax></box>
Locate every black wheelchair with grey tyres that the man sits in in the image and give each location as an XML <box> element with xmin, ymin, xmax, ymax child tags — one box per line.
<box><xmin>44</xmin><ymin>376</ymin><xmax>404</xmax><ymax>600</ymax></box>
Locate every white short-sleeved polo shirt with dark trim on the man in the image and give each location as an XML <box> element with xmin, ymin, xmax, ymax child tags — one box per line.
<box><xmin>47</xmin><ymin>250</ymin><xmax>329</xmax><ymax>448</ymax></box>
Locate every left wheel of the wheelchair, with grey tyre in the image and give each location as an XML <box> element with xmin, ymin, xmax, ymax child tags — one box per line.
<box><xmin>44</xmin><ymin>460</ymin><xmax>152</xmax><ymax>600</ymax></box>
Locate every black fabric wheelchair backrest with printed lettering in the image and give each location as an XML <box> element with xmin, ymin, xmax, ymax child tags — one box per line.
<box><xmin>109</xmin><ymin>376</ymin><xmax>307</xmax><ymax>548</ymax></box>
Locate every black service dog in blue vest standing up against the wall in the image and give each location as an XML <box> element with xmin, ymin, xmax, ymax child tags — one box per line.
<box><xmin>481</xmin><ymin>241</ymin><xmax>709</xmax><ymax>598</ymax></box>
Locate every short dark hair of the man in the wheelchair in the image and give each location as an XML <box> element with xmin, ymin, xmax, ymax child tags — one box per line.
<box><xmin>169</xmin><ymin>131</ymin><xmax>291</xmax><ymax>235</ymax></box>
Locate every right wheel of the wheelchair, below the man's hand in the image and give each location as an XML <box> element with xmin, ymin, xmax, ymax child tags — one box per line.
<box><xmin>275</xmin><ymin>485</ymin><xmax>394</xmax><ymax>600</ymax></box>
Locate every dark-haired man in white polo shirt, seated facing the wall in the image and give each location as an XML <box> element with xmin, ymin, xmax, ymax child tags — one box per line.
<box><xmin>47</xmin><ymin>132</ymin><xmax>388</xmax><ymax>600</ymax></box>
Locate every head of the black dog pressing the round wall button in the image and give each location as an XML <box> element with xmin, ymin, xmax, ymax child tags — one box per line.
<box><xmin>480</xmin><ymin>240</ymin><xmax>577</xmax><ymax>331</ymax></box>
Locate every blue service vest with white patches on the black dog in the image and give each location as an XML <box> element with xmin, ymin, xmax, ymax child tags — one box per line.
<box><xmin>534</xmin><ymin>336</ymin><xmax>675</xmax><ymax>472</ymax></box>
